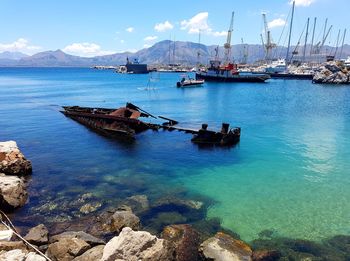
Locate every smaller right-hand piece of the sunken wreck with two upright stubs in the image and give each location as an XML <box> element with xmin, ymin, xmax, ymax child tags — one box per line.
<box><xmin>191</xmin><ymin>123</ymin><xmax>241</xmax><ymax>146</ymax></box>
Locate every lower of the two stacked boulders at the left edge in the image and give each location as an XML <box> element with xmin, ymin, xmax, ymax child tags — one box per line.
<box><xmin>0</xmin><ymin>174</ymin><xmax>28</xmax><ymax>210</ymax></box>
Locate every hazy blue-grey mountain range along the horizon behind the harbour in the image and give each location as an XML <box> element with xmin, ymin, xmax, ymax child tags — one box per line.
<box><xmin>0</xmin><ymin>40</ymin><xmax>350</xmax><ymax>67</ymax></box>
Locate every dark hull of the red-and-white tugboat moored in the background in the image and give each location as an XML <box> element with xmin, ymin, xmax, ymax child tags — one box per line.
<box><xmin>196</xmin><ymin>73</ymin><xmax>270</xmax><ymax>83</ymax></box>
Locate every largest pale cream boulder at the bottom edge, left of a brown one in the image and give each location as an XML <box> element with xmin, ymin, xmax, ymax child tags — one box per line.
<box><xmin>101</xmin><ymin>227</ymin><xmax>175</xmax><ymax>261</ymax></box>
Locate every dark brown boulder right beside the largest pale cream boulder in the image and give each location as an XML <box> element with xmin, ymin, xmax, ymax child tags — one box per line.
<box><xmin>162</xmin><ymin>224</ymin><xmax>200</xmax><ymax>261</ymax></box>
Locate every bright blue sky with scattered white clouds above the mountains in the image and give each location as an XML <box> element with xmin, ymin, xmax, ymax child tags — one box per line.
<box><xmin>0</xmin><ymin>0</ymin><xmax>350</xmax><ymax>56</ymax></box>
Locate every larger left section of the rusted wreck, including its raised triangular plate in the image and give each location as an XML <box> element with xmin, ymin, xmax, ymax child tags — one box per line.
<box><xmin>61</xmin><ymin>103</ymin><xmax>156</xmax><ymax>139</ymax></box>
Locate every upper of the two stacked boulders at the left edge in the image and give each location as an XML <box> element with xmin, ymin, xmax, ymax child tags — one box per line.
<box><xmin>0</xmin><ymin>141</ymin><xmax>32</xmax><ymax>176</ymax></box>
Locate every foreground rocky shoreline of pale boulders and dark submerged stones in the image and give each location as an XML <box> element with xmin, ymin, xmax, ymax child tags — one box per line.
<box><xmin>0</xmin><ymin>141</ymin><xmax>350</xmax><ymax>261</ymax></box>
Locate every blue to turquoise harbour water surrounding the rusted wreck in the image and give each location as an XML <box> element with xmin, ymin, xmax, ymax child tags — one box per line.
<box><xmin>0</xmin><ymin>68</ymin><xmax>350</xmax><ymax>241</ymax></box>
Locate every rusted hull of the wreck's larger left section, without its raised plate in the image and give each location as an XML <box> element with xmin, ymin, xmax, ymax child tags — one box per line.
<box><xmin>61</xmin><ymin>106</ymin><xmax>151</xmax><ymax>138</ymax></box>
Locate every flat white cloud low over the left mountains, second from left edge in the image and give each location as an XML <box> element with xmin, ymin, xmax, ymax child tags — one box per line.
<box><xmin>63</xmin><ymin>43</ymin><xmax>115</xmax><ymax>57</ymax></box>
